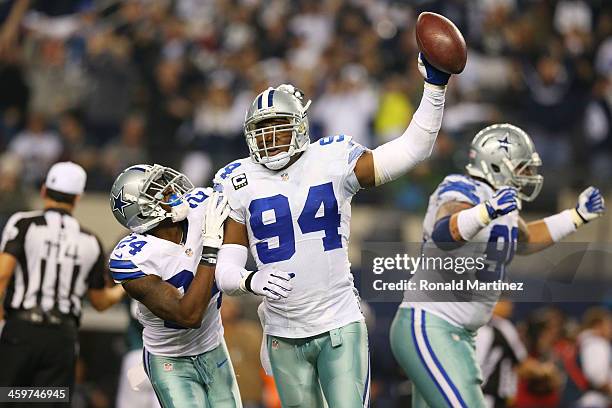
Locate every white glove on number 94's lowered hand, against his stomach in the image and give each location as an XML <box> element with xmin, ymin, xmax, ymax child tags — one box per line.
<box><xmin>240</xmin><ymin>267</ymin><xmax>295</xmax><ymax>300</ymax></box>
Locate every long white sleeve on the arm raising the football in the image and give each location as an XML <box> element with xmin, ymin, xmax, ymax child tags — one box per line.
<box><xmin>372</xmin><ymin>84</ymin><xmax>446</xmax><ymax>186</ymax></box>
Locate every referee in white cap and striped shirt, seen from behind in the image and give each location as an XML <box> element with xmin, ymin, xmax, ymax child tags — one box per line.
<box><xmin>0</xmin><ymin>162</ymin><xmax>124</xmax><ymax>396</ymax></box>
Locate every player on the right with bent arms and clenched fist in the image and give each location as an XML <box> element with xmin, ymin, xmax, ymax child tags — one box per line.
<box><xmin>391</xmin><ymin>124</ymin><xmax>604</xmax><ymax>408</ymax></box>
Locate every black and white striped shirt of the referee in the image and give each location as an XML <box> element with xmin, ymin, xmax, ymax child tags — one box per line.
<box><xmin>0</xmin><ymin>209</ymin><xmax>106</xmax><ymax>319</ymax></box>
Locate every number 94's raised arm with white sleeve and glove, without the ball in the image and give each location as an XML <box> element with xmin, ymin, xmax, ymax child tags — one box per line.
<box><xmin>354</xmin><ymin>56</ymin><xmax>450</xmax><ymax>187</ymax></box>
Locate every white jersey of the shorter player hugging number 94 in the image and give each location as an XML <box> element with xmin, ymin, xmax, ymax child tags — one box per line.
<box><xmin>109</xmin><ymin>188</ymin><xmax>223</xmax><ymax>357</ymax></box>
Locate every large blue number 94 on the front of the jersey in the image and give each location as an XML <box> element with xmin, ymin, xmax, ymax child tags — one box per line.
<box><xmin>249</xmin><ymin>182</ymin><xmax>342</xmax><ymax>264</ymax></box>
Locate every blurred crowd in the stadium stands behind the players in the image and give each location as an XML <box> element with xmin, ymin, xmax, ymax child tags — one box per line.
<box><xmin>0</xmin><ymin>0</ymin><xmax>612</xmax><ymax>407</ymax></box>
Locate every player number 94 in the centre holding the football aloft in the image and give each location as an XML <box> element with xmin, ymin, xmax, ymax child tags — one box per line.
<box><xmin>215</xmin><ymin>55</ymin><xmax>450</xmax><ymax>408</ymax></box>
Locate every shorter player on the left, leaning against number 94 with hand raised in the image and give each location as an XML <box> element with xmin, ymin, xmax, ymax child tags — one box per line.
<box><xmin>109</xmin><ymin>164</ymin><xmax>242</xmax><ymax>408</ymax></box>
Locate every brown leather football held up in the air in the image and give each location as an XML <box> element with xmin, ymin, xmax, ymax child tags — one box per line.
<box><xmin>416</xmin><ymin>12</ymin><xmax>467</xmax><ymax>74</ymax></box>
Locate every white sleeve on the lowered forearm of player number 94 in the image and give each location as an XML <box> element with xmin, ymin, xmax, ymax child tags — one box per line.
<box><xmin>215</xmin><ymin>244</ymin><xmax>250</xmax><ymax>296</ymax></box>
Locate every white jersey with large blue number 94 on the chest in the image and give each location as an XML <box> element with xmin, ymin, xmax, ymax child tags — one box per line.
<box><xmin>215</xmin><ymin>135</ymin><xmax>365</xmax><ymax>338</ymax></box>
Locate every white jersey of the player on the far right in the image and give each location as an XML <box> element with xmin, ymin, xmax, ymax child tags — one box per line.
<box><xmin>400</xmin><ymin>174</ymin><xmax>519</xmax><ymax>330</ymax></box>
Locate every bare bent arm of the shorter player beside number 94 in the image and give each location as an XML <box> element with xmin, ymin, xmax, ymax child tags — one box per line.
<box><xmin>123</xmin><ymin>265</ymin><xmax>215</xmax><ymax>329</ymax></box>
